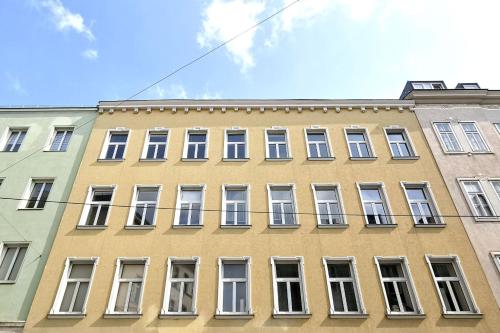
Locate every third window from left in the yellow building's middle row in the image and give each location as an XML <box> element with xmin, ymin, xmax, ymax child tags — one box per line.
<box><xmin>174</xmin><ymin>185</ymin><xmax>205</xmax><ymax>226</ymax></box>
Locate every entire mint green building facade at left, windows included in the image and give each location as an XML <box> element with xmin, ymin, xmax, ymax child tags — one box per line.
<box><xmin>0</xmin><ymin>107</ymin><xmax>97</xmax><ymax>333</ymax></box>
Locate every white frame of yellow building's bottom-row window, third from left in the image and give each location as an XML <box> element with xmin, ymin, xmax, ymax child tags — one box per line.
<box><xmin>160</xmin><ymin>257</ymin><xmax>200</xmax><ymax>318</ymax></box>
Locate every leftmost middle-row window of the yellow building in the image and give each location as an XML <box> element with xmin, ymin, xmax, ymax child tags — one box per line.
<box><xmin>78</xmin><ymin>186</ymin><xmax>115</xmax><ymax>227</ymax></box>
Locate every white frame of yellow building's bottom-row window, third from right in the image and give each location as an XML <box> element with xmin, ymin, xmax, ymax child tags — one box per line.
<box><xmin>322</xmin><ymin>256</ymin><xmax>367</xmax><ymax>318</ymax></box>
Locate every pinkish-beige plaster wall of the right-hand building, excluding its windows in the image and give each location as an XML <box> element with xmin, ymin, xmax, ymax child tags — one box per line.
<box><xmin>416</xmin><ymin>105</ymin><xmax>500</xmax><ymax>306</ymax></box>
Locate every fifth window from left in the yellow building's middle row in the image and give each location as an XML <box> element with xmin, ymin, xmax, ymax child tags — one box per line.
<box><xmin>267</xmin><ymin>185</ymin><xmax>298</xmax><ymax>226</ymax></box>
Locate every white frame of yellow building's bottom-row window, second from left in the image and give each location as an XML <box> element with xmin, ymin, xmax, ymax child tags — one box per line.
<box><xmin>104</xmin><ymin>257</ymin><xmax>149</xmax><ymax>318</ymax></box>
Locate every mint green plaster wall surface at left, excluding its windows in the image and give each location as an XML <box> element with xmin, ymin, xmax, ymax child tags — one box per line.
<box><xmin>0</xmin><ymin>109</ymin><xmax>96</xmax><ymax>324</ymax></box>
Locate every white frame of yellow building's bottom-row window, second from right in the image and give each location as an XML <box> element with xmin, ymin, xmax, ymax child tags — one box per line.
<box><xmin>374</xmin><ymin>256</ymin><xmax>424</xmax><ymax>318</ymax></box>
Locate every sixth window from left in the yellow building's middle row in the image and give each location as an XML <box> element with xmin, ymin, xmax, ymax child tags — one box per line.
<box><xmin>312</xmin><ymin>184</ymin><xmax>345</xmax><ymax>226</ymax></box>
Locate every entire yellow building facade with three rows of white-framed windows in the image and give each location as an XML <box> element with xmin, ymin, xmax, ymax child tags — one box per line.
<box><xmin>25</xmin><ymin>100</ymin><xmax>500</xmax><ymax>332</ymax></box>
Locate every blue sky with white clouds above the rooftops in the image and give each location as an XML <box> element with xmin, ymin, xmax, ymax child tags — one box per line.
<box><xmin>0</xmin><ymin>0</ymin><xmax>500</xmax><ymax>105</ymax></box>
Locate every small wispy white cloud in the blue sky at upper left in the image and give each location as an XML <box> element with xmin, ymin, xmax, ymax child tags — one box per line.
<box><xmin>37</xmin><ymin>0</ymin><xmax>95</xmax><ymax>40</ymax></box>
